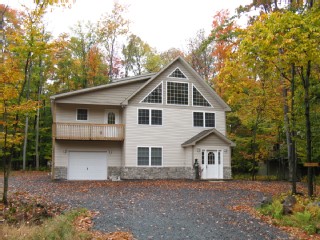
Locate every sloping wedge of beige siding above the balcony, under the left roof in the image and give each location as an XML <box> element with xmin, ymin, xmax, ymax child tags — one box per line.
<box><xmin>56</xmin><ymin>82</ymin><xmax>144</xmax><ymax>105</ymax></box>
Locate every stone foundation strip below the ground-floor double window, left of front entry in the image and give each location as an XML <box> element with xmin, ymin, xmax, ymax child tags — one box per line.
<box><xmin>121</xmin><ymin>167</ymin><xmax>195</xmax><ymax>179</ymax></box>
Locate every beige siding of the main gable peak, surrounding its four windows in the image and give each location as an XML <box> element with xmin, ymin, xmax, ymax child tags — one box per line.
<box><xmin>129</xmin><ymin>63</ymin><xmax>223</xmax><ymax>111</ymax></box>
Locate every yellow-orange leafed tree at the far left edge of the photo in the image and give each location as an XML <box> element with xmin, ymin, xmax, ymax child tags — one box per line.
<box><xmin>0</xmin><ymin>5</ymin><xmax>36</xmax><ymax>204</ymax></box>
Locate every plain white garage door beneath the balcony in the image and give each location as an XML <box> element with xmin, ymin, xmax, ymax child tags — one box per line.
<box><xmin>68</xmin><ymin>152</ymin><xmax>107</xmax><ymax>180</ymax></box>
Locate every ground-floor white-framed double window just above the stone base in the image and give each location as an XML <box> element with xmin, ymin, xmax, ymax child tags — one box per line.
<box><xmin>137</xmin><ymin>147</ymin><xmax>162</xmax><ymax>167</ymax></box>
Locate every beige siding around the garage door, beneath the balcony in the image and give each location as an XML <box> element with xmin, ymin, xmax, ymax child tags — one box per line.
<box><xmin>55</xmin><ymin>140</ymin><xmax>122</xmax><ymax>167</ymax></box>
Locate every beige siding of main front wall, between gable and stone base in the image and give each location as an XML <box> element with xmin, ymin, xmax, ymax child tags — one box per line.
<box><xmin>124</xmin><ymin>105</ymin><xmax>225</xmax><ymax>167</ymax></box>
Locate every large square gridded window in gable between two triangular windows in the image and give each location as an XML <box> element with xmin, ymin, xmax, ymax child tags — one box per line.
<box><xmin>167</xmin><ymin>82</ymin><xmax>189</xmax><ymax>105</ymax></box>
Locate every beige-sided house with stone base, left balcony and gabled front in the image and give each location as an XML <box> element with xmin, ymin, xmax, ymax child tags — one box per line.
<box><xmin>51</xmin><ymin>57</ymin><xmax>234</xmax><ymax>180</ymax></box>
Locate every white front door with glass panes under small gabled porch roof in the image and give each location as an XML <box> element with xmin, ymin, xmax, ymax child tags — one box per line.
<box><xmin>202</xmin><ymin>150</ymin><xmax>223</xmax><ymax>179</ymax></box>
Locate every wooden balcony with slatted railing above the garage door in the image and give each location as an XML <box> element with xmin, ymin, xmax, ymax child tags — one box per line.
<box><xmin>52</xmin><ymin>123</ymin><xmax>124</xmax><ymax>141</ymax></box>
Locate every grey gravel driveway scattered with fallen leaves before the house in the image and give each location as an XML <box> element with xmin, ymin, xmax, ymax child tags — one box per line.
<box><xmin>10</xmin><ymin>173</ymin><xmax>298</xmax><ymax>240</ymax></box>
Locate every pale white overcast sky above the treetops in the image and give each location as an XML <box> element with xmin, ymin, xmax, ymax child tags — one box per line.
<box><xmin>1</xmin><ymin>0</ymin><xmax>252</xmax><ymax>51</ymax></box>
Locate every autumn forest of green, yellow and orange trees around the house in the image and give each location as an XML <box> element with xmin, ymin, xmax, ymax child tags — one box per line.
<box><xmin>0</xmin><ymin>0</ymin><xmax>320</xmax><ymax>201</ymax></box>
